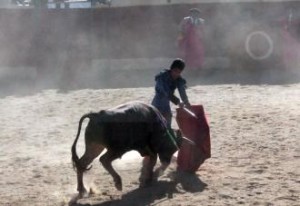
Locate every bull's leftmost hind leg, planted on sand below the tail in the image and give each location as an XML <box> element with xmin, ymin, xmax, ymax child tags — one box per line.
<box><xmin>77</xmin><ymin>143</ymin><xmax>104</xmax><ymax>197</ymax></box>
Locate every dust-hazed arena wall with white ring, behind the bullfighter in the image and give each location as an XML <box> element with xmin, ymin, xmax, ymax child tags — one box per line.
<box><xmin>0</xmin><ymin>1</ymin><xmax>300</xmax><ymax>96</ymax></box>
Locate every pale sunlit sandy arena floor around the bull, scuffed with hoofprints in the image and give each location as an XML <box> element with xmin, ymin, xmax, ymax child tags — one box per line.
<box><xmin>0</xmin><ymin>84</ymin><xmax>300</xmax><ymax>206</ymax></box>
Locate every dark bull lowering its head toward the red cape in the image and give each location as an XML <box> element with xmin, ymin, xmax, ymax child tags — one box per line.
<box><xmin>72</xmin><ymin>102</ymin><xmax>182</xmax><ymax>196</ymax></box>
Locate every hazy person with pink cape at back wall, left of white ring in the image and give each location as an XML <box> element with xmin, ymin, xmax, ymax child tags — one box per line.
<box><xmin>178</xmin><ymin>8</ymin><xmax>204</xmax><ymax>72</ymax></box>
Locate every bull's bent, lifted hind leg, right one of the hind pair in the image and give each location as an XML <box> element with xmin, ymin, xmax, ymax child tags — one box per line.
<box><xmin>100</xmin><ymin>150</ymin><xmax>122</xmax><ymax>191</ymax></box>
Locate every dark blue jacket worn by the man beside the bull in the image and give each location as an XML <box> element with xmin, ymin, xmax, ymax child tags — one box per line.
<box><xmin>152</xmin><ymin>70</ymin><xmax>189</xmax><ymax>113</ymax></box>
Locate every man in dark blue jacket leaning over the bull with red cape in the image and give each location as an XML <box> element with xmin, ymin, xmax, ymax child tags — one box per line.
<box><xmin>152</xmin><ymin>59</ymin><xmax>190</xmax><ymax>128</ymax></box>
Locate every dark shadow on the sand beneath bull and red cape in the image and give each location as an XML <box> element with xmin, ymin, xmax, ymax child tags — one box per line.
<box><xmin>69</xmin><ymin>172</ymin><xmax>207</xmax><ymax>206</ymax></box>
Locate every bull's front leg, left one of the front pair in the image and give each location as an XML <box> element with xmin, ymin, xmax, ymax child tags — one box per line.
<box><xmin>139</xmin><ymin>154</ymin><xmax>157</xmax><ymax>187</ymax></box>
